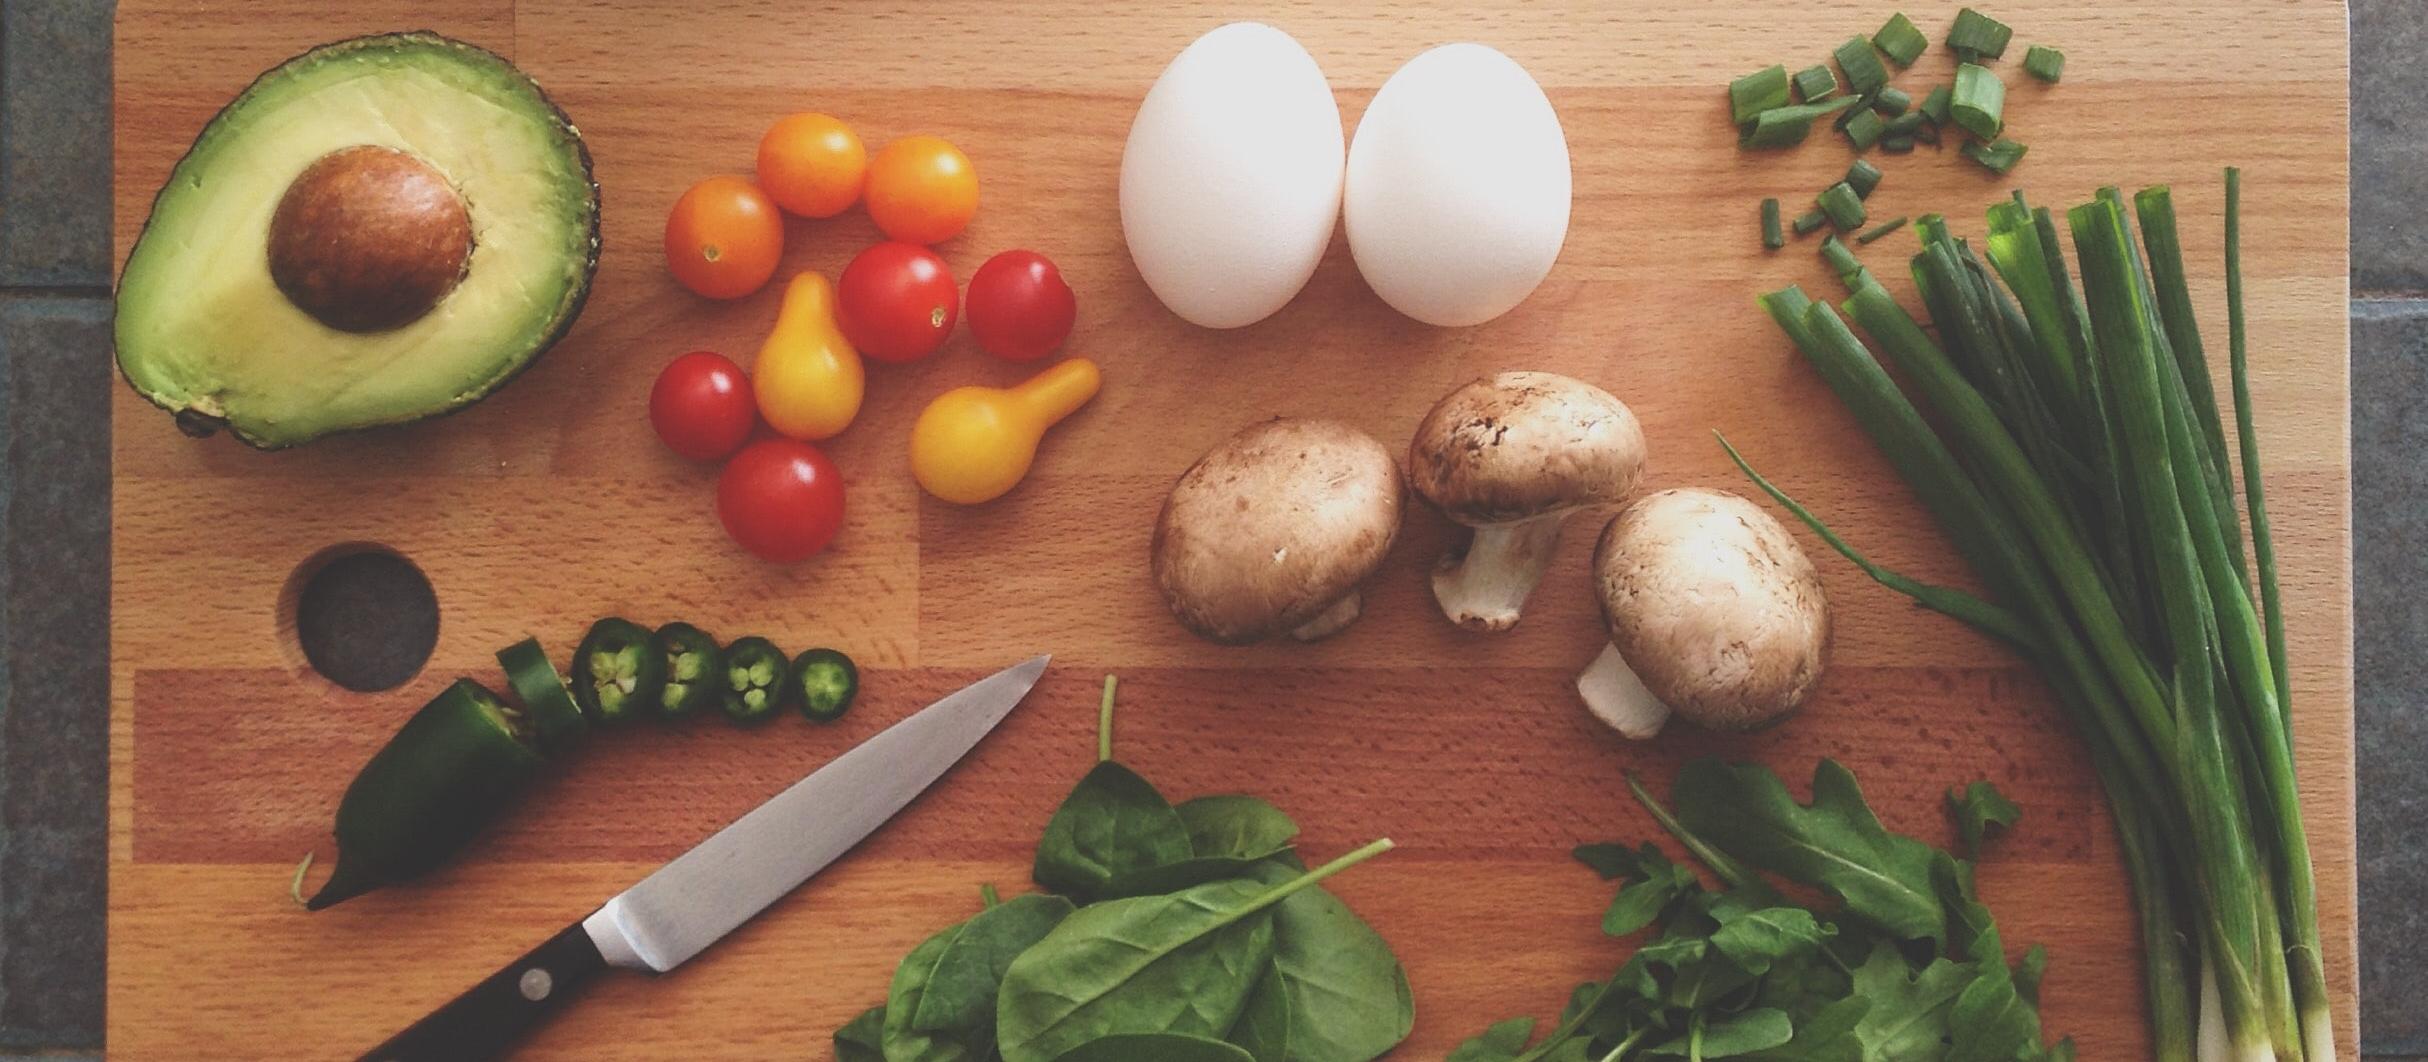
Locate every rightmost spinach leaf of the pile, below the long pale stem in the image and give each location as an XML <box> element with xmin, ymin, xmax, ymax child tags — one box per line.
<box><xmin>1231</xmin><ymin>863</ymin><xmax>1416</xmax><ymax>1062</ymax></box>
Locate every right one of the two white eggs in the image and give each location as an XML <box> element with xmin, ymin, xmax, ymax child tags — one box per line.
<box><xmin>1343</xmin><ymin>44</ymin><xmax>1568</xmax><ymax>326</ymax></box>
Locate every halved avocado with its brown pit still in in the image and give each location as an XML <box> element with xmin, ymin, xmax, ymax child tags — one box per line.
<box><xmin>117</xmin><ymin>32</ymin><xmax>600</xmax><ymax>450</ymax></box>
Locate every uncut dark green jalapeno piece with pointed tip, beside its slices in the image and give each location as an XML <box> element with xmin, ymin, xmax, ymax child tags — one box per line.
<box><xmin>306</xmin><ymin>678</ymin><xmax>539</xmax><ymax>911</ymax></box>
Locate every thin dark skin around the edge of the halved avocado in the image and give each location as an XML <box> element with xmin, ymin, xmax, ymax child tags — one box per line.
<box><xmin>109</xmin><ymin>29</ymin><xmax>600</xmax><ymax>450</ymax></box>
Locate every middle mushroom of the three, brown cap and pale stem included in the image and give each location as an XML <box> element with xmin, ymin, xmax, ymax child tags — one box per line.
<box><xmin>1408</xmin><ymin>372</ymin><xmax>1644</xmax><ymax>632</ymax></box>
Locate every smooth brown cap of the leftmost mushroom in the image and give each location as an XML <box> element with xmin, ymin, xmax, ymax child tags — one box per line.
<box><xmin>1153</xmin><ymin>418</ymin><xmax>1401</xmax><ymax>644</ymax></box>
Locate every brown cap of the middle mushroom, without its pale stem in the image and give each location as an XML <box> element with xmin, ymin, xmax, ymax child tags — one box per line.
<box><xmin>1408</xmin><ymin>372</ymin><xmax>1644</xmax><ymax>527</ymax></box>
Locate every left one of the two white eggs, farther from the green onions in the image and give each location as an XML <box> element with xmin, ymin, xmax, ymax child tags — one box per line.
<box><xmin>1122</xmin><ymin>22</ymin><xmax>1343</xmax><ymax>328</ymax></box>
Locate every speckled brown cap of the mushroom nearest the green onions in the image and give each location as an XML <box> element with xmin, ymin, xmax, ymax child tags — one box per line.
<box><xmin>1593</xmin><ymin>488</ymin><xmax>1828</xmax><ymax>731</ymax></box>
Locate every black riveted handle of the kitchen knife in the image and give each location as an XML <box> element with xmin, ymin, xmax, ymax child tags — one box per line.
<box><xmin>362</xmin><ymin>921</ymin><xmax>607</xmax><ymax>1062</ymax></box>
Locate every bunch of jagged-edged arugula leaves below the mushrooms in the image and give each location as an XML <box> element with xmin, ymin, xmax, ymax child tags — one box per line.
<box><xmin>1450</xmin><ymin>758</ymin><xmax>2074</xmax><ymax>1062</ymax></box>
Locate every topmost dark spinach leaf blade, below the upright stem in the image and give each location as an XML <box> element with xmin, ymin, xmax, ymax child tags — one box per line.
<box><xmin>1032</xmin><ymin>761</ymin><xmax>1195</xmax><ymax>904</ymax></box>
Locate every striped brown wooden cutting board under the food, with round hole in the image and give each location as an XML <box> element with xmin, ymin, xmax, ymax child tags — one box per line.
<box><xmin>109</xmin><ymin>0</ymin><xmax>2358</xmax><ymax>1060</ymax></box>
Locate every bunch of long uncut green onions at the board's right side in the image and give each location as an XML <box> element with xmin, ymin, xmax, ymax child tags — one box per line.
<box><xmin>1721</xmin><ymin>170</ymin><xmax>2336</xmax><ymax>1062</ymax></box>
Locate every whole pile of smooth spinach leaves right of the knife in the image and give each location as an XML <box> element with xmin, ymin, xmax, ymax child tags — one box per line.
<box><xmin>835</xmin><ymin>676</ymin><xmax>1416</xmax><ymax>1062</ymax></box>
